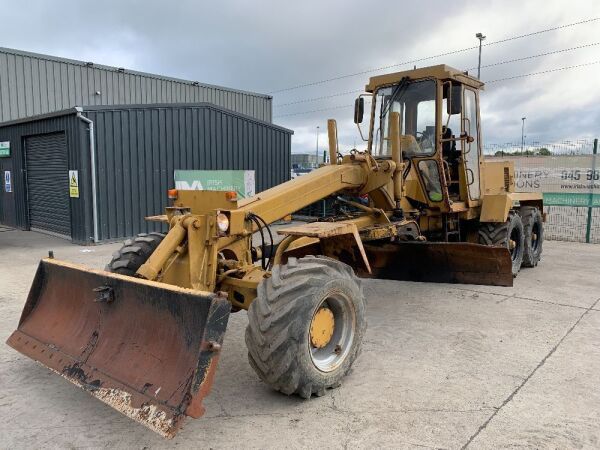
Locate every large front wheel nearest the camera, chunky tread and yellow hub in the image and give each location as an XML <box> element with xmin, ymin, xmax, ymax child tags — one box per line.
<box><xmin>246</xmin><ymin>256</ymin><xmax>367</xmax><ymax>398</ymax></box>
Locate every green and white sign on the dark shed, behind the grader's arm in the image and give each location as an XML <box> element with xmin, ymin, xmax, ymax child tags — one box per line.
<box><xmin>175</xmin><ymin>170</ymin><xmax>255</xmax><ymax>198</ymax></box>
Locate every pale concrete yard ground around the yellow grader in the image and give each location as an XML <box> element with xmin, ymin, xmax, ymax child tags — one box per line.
<box><xmin>0</xmin><ymin>230</ymin><xmax>600</xmax><ymax>449</ymax></box>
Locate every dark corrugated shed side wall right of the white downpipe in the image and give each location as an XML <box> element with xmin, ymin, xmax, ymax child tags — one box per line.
<box><xmin>84</xmin><ymin>104</ymin><xmax>292</xmax><ymax>240</ymax></box>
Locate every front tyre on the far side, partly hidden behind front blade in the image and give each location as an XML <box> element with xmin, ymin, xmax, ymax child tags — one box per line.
<box><xmin>105</xmin><ymin>233</ymin><xmax>165</xmax><ymax>277</ymax></box>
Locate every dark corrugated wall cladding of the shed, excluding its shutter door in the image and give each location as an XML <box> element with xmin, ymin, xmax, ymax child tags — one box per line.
<box><xmin>0</xmin><ymin>104</ymin><xmax>292</xmax><ymax>243</ymax></box>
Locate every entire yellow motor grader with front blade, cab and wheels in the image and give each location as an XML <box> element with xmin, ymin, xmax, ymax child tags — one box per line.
<box><xmin>8</xmin><ymin>65</ymin><xmax>543</xmax><ymax>437</ymax></box>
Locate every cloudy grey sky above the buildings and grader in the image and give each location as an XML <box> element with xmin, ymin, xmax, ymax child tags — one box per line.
<box><xmin>0</xmin><ymin>0</ymin><xmax>600</xmax><ymax>152</ymax></box>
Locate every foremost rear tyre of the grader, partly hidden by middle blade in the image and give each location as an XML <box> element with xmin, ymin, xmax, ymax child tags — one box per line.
<box><xmin>479</xmin><ymin>211</ymin><xmax>525</xmax><ymax>277</ymax></box>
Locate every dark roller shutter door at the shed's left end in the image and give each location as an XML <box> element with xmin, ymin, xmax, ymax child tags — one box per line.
<box><xmin>25</xmin><ymin>133</ymin><xmax>71</xmax><ymax>237</ymax></box>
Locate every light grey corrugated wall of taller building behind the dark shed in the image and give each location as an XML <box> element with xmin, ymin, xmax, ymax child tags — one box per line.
<box><xmin>0</xmin><ymin>47</ymin><xmax>272</xmax><ymax>122</ymax></box>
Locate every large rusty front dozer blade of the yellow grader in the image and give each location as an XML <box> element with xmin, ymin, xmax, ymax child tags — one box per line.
<box><xmin>7</xmin><ymin>259</ymin><xmax>231</xmax><ymax>438</ymax></box>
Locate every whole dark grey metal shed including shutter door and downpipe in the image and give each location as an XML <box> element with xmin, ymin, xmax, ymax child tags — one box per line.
<box><xmin>0</xmin><ymin>103</ymin><xmax>293</xmax><ymax>243</ymax></box>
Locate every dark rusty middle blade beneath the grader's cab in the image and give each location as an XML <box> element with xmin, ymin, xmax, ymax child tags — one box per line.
<box><xmin>365</xmin><ymin>242</ymin><xmax>513</xmax><ymax>286</ymax></box>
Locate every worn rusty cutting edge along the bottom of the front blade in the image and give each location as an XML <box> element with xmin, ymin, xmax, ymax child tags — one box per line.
<box><xmin>6</xmin><ymin>330</ymin><xmax>190</xmax><ymax>439</ymax></box>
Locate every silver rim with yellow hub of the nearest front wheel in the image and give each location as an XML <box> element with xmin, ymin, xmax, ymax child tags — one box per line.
<box><xmin>308</xmin><ymin>292</ymin><xmax>356</xmax><ymax>372</ymax></box>
